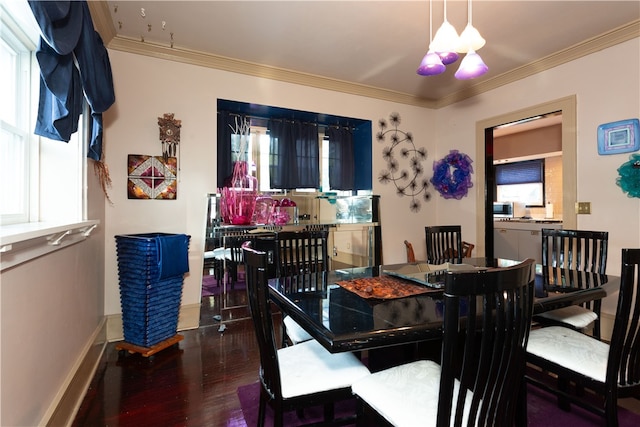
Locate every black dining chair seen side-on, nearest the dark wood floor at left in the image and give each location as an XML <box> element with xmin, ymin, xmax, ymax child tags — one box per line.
<box><xmin>243</xmin><ymin>245</ymin><xmax>369</xmax><ymax>426</ymax></box>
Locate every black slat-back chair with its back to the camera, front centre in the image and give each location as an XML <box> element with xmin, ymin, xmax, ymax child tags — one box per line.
<box><xmin>352</xmin><ymin>259</ymin><xmax>535</xmax><ymax>427</ymax></box>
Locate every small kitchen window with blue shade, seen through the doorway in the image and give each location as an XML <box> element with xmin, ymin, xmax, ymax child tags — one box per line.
<box><xmin>495</xmin><ymin>159</ymin><xmax>544</xmax><ymax>206</ymax></box>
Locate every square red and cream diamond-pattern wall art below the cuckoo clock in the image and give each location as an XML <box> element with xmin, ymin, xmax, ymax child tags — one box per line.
<box><xmin>127</xmin><ymin>154</ymin><xmax>178</xmax><ymax>200</ymax></box>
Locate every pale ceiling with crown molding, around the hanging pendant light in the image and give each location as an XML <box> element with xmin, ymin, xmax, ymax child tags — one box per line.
<box><xmin>90</xmin><ymin>0</ymin><xmax>640</xmax><ymax>108</ymax></box>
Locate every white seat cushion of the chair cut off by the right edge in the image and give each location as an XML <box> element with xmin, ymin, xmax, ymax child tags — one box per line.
<box><xmin>527</xmin><ymin>326</ymin><xmax>609</xmax><ymax>382</ymax></box>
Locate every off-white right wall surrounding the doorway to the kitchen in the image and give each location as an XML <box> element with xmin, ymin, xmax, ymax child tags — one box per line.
<box><xmin>437</xmin><ymin>39</ymin><xmax>640</xmax><ymax>313</ymax></box>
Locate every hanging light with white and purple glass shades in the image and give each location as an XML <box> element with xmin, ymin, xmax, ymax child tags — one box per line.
<box><xmin>417</xmin><ymin>0</ymin><xmax>489</xmax><ymax>80</ymax></box>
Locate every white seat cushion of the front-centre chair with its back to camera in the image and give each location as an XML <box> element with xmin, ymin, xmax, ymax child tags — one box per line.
<box><xmin>351</xmin><ymin>360</ymin><xmax>473</xmax><ymax>427</ymax></box>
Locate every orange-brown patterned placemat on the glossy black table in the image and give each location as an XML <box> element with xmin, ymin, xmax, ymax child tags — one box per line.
<box><xmin>336</xmin><ymin>276</ymin><xmax>442</xmax><ymax>299</ymax></box>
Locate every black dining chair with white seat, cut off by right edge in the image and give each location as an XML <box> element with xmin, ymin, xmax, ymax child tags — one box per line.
<box><xmin>523</xmin><ymin>249</ymin><xmax>640</xmax><ymax>427</ymax></box>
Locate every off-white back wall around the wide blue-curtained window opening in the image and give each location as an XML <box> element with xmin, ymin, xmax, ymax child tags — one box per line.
<box><xmin>104</xmin><ymin>51</ymin><xmax>437</xmax><ymax>327</ymax></box>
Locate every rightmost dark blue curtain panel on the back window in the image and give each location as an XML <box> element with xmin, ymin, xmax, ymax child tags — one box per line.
<box><xmin>325</xmin><ymin>126</ymin><xmax>355</xmax><ymax>191</ymax></box>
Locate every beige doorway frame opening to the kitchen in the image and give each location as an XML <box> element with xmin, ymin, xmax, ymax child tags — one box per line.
<box><xmin>476</xmin><ymin>95</ymin><xmax>577</xmax><ymax>257</ymax></box>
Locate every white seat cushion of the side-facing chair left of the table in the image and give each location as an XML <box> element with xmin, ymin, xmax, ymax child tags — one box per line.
<box><xmin>278</xmin><ymin>340</ymin><xmax>369</xmax><ymax>398</ymax></box>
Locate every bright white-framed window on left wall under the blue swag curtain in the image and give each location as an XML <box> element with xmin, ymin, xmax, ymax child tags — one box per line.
<box><xmin>0</xmin><ymin>2</ymin><xmax>86</xmax><ymax>225</ymax></box>
